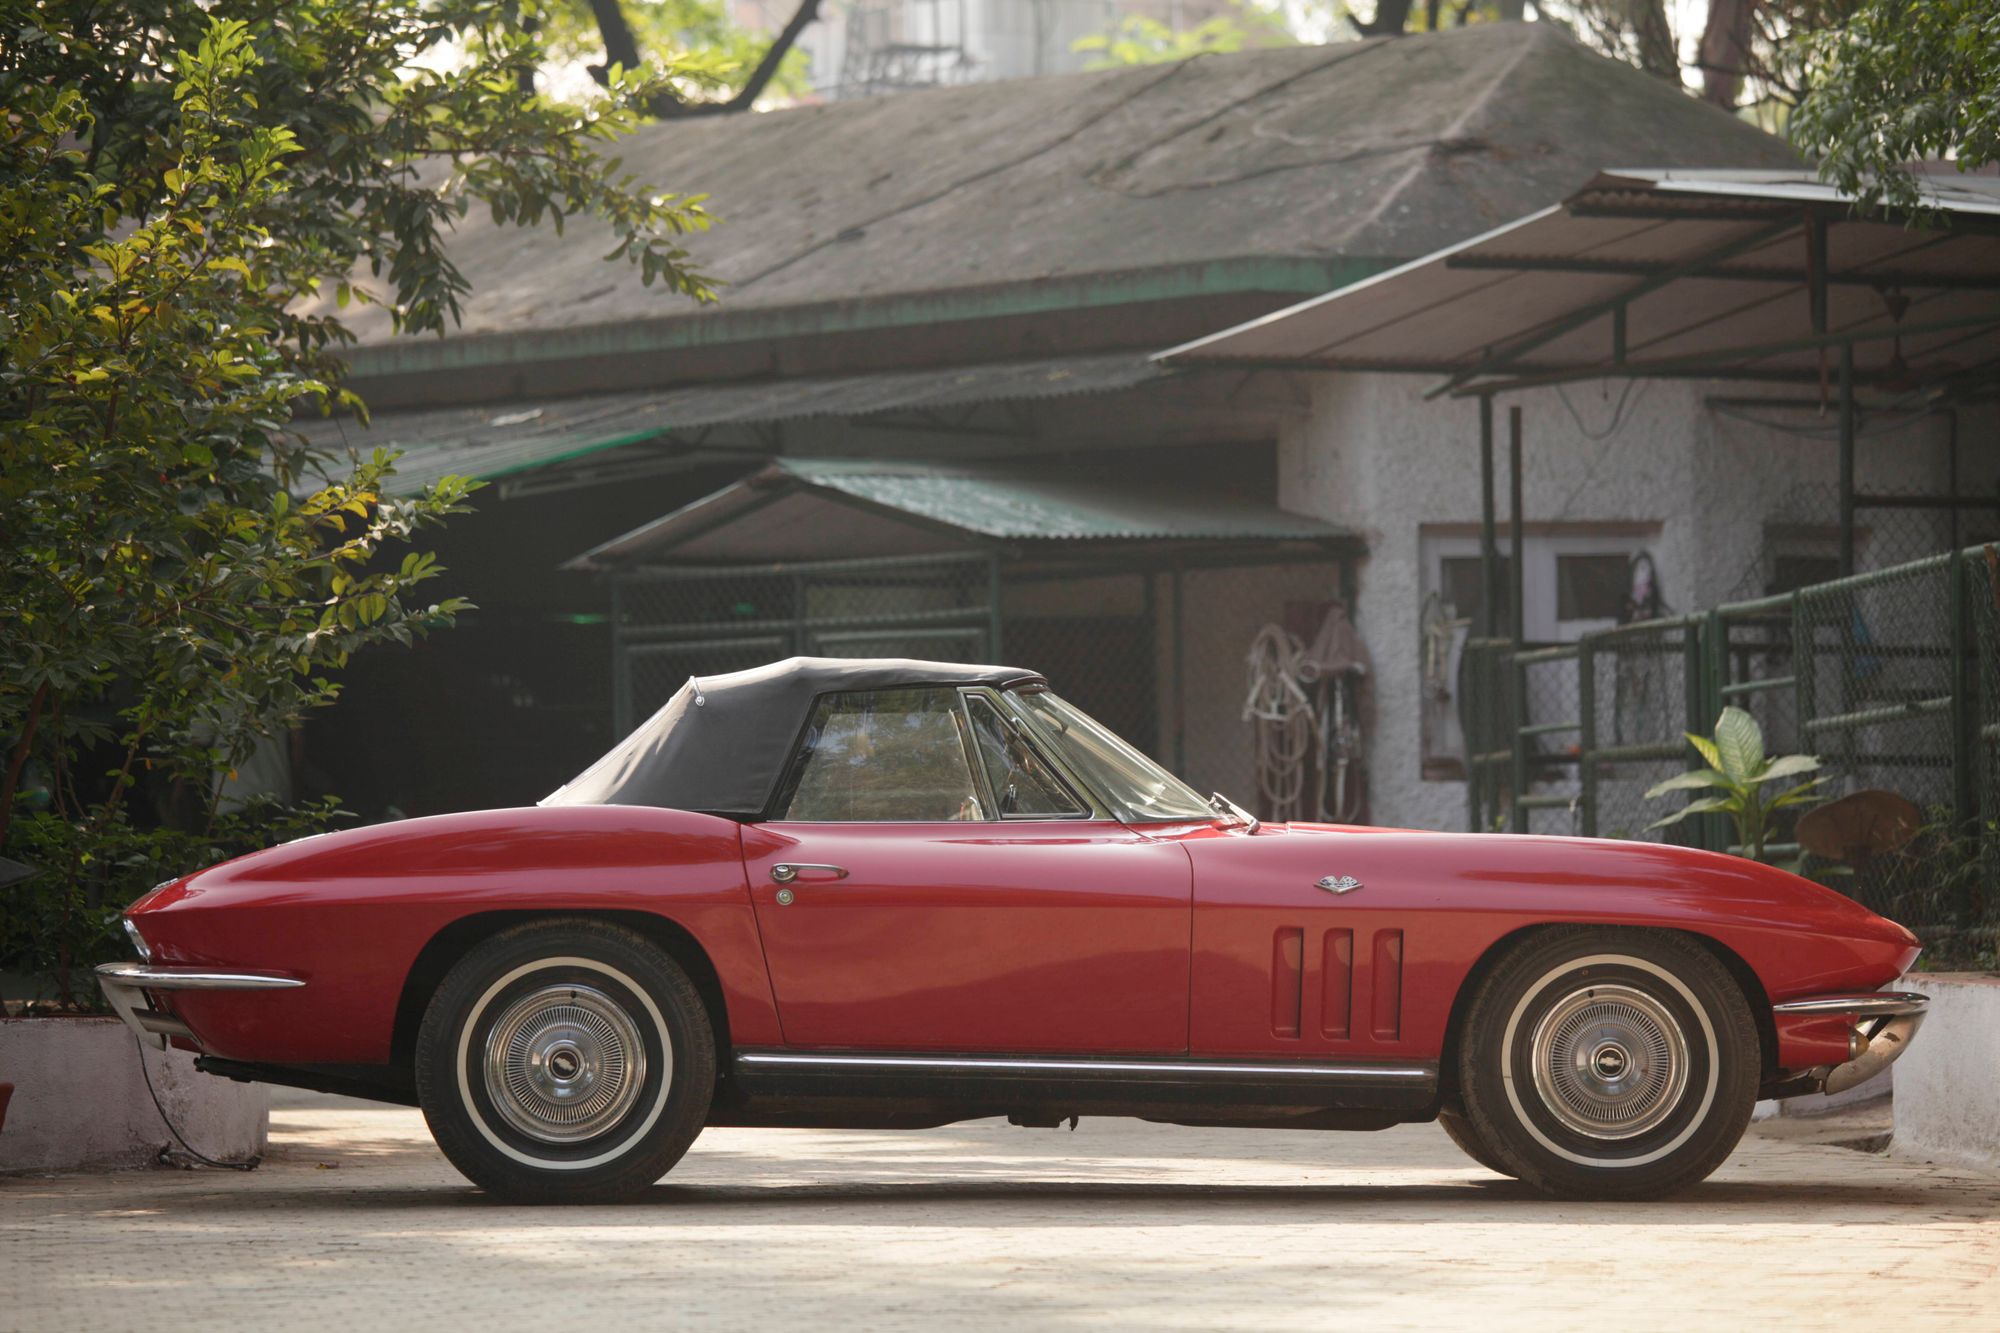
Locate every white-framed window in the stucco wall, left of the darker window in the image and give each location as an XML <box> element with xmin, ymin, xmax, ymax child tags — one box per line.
<box><xmin>1418</xmin><ymin>522</ymin><xmax>1660</xmax><ymax>781</ymax></box>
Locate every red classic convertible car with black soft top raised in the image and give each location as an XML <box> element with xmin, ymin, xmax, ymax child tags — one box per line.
<box><xmin>100</xmin><ymin>658</ymin><xmax>1924</xmax><ymax>1201</ymax></box>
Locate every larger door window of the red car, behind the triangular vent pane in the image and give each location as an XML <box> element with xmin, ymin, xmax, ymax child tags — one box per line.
<box><xmin>780</xmin><ymin>689</ymin><xmax>986</xmax><ymax>823</ymax></box>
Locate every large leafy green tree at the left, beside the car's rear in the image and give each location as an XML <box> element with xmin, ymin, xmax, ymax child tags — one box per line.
<box><xmin>0</xmin><ymin>0</ymin><xmax>708</xmax><ymax>999</ymax></box>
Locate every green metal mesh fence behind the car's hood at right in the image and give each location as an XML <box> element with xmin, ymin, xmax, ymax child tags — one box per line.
<box><xmin>1460</xmin><ymin>548</ymin><xmax>2000</xmax><ymax>965</ymax></box>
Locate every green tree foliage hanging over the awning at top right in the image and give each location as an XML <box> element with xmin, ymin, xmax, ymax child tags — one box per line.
<box><xmin>1792</xmin><ymin>0</ymin><xmax>2000</xmax><ymax>212</ymax></box>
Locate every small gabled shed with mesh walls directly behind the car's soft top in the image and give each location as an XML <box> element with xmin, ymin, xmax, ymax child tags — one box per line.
<box><xmin>570</xmin><ymin>458</ymin><xmax>1358</xmax><ymax>791</ymax></box>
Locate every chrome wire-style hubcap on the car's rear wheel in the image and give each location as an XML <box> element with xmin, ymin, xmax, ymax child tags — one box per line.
<box><xmin>486</xmin><ymin>985</ymin><xmax>646</xmax><ymax>1143</ymax></box>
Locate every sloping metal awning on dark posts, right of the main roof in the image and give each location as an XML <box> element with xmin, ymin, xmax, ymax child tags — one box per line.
<box><xmin>1160</xmin><ymin>170</ymin><xmax>2000</xmax><ymax>396</ymax></box>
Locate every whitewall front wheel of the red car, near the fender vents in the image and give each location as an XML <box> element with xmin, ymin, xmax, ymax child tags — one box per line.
<box><xmin>1458</xmin><ymin>927</ymin><xmax>1762</xmax><ymax>1199</ymax></box>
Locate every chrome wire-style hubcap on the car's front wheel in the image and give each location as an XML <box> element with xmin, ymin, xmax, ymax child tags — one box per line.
<box><xmin>1530</xmin><ymin>985</ymin><xmax>1688</xmax><ymax>1139</ymax></box>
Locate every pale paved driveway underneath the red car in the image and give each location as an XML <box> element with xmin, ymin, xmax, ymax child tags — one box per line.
<box><xmin>0</xmin><ymin>1099</ymin><xmax>2000</xmax><ymax>1333</ymax></box>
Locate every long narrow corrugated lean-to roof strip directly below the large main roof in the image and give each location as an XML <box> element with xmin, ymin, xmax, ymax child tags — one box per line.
<box><xmin>302</xmin><ymin>352</ymin><xmax>1174</xmax><ymax>492</ymax></box>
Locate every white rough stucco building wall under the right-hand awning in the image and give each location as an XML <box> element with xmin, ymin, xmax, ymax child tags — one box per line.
<box><xmin>1278</xmin><ymin>374</ymin><xmax>2000</xmax><ymax>829</ymax></box>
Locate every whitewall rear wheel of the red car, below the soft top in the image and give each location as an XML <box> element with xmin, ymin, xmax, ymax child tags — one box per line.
<box><xmin>416</xmin><ymin>919</ymin><xmax>716</xmax><ymax>1203</ymax></box>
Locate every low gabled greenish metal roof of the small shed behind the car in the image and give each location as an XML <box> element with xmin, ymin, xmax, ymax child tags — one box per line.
<box><xmin>566</xmin><ymin>458</ymin><xmax>1356</xmax><ymax>568</ymax></box>
